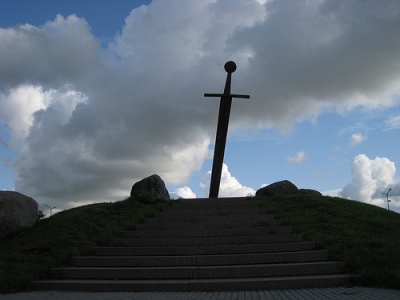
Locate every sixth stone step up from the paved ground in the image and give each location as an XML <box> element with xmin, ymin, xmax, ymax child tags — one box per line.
<box><xmin>119</xmin><ymin>225</ymin><xmax>292</xmax><ymax>238</ymax></box>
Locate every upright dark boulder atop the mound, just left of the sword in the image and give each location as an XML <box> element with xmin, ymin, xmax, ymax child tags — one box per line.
<box><xmin>131</xmin><ymin>174</ymin><xmax>170</xmax><ymax>204</ymax></box>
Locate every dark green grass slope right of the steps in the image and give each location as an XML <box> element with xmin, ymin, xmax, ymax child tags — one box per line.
<box><xmin>256</xmin><ymin>195</ymin><xmax>400</xmax><ymax>289</ymax></box>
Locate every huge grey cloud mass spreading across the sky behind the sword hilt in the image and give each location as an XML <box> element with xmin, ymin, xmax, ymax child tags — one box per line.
<box><xmin>0</xmin><ymin>0</ymin><xmax>400</xmax><ymax>208</ymax></box>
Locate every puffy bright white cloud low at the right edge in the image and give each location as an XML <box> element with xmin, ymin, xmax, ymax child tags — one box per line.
<box><xmin>339</xmin><ymin>154</ymin><xmax>400</xmax><ymax>207</ymax></box>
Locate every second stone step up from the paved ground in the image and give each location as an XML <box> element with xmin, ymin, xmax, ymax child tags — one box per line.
<box><xmin>54</xmin><ymin>262</ymin><xmax>344</xmax><ymax>280</ymax></box>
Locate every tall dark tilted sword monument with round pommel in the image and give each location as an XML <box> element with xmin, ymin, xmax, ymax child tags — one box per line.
<box><xmin>204</xmin><ymin>61</ymin><xmax>250</xmax><ymax>198</ymax></box>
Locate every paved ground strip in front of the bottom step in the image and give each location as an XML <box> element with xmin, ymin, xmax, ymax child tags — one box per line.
<box><xmin>0</xmin><ymin>287</ymin><xmax>400</xmax><ymax>300</ymax></box>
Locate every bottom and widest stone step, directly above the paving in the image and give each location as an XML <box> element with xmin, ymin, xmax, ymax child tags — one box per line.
<box><xmin>33</xmin><ymin>274</ymin><xmax>349</xmax><ymax>292</ymax></box>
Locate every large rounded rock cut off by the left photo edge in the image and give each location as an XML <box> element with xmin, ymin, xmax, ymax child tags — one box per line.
<box><xmin>0</xmin><ymin>191</ymin><xmax>38</xmax><ymax>239</ymax></box>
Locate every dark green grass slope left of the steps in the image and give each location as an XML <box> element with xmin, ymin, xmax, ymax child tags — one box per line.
<box><xmin>0</xmin><ymin>199</ymin><xmax>164</xmax><ymax>293</ymax></box>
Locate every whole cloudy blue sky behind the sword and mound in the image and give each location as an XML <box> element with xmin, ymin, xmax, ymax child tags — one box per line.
<box><xmin>0</xmin><ymin>0</ymin><xmax>400</xmax><ymax>212</ymax></box>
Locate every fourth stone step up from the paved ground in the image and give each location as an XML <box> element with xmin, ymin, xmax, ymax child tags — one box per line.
<box><xmin>92</xmin><ymin>241</ymin><xmax>315</xmax><ymax>256</ymax></box>
